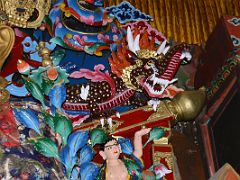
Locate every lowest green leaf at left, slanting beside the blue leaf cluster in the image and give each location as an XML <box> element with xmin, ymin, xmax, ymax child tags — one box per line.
<box><xmin>29</xmin><ymin>137</ymin><xmax>59</xmax><ymax>159</ymax></box>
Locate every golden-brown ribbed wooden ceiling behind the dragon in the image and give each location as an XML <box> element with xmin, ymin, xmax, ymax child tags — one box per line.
<box><xmin>105</xmin><ymin>0</ymin><xmax>240</xmax><ymax>44</ymax></box>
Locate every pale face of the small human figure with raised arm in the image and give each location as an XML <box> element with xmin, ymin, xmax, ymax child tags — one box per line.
<box><xmin>104</xmin><ymin>140</ymin><xmax>121</xmax><ymax>160</ymax></box>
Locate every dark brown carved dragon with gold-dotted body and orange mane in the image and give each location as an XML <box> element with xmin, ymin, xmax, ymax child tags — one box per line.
<box><xmin>63</xmin><ymin>28</ymin><xmax>191</xmax><ymax>118</ymax></box>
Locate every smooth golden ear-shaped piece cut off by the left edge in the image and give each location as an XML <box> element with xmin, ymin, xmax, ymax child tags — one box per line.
<box><xmin>0</xmin><ymin>25</ymin><xmax>15</xmax><ymax>70</ymax></box>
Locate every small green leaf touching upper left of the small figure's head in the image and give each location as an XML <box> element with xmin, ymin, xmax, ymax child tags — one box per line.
<box><xmin>90</xmin><ymin>128</ymin><xmax>108</xmax><ymax>146</ymax></box>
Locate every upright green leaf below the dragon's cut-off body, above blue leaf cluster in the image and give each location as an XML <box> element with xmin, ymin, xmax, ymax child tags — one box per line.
<box><xmin>54</xmin><ymin>113</ymin><xmax>73</xmax><ymax>146</ymax></box>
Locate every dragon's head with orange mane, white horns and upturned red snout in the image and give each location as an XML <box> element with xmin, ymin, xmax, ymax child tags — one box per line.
<box><xmin>109</xmin><ymin>27</ymin><xmax>191</xmax><ymax>98</ymax></box>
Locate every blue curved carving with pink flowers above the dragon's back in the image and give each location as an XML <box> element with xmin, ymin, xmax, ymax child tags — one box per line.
<box><xmin>49</xmin><ymin>0</ymin><xmax>122</xmax><ymax>56</ymax></box>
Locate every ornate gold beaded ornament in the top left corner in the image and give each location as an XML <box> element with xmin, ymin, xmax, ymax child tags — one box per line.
<box><xmin>0</xmin><ymin>0</ymin><xmax>51</xmax><ymax>28</ymax></box>
